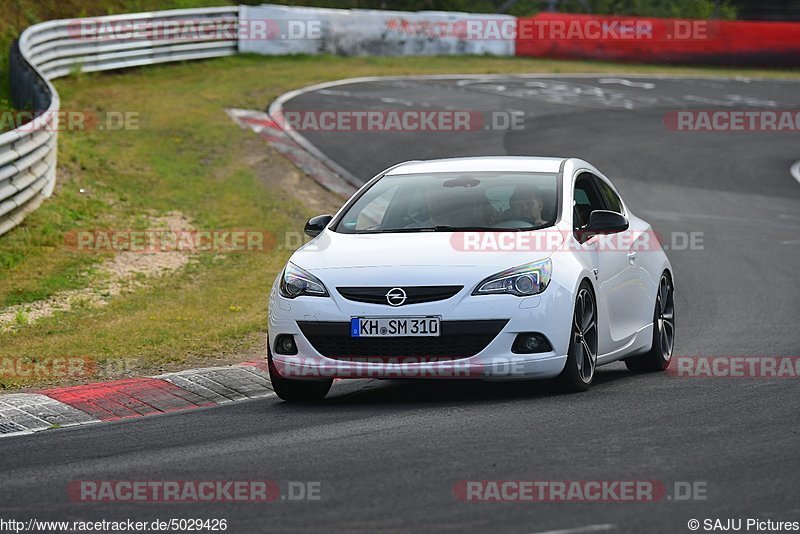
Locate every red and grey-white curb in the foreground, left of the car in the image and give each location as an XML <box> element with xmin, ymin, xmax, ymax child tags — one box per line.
<box><xmin>0</xmin><ymin>362</ymin><xmax>274</xmax><ymax>437</ymax></box>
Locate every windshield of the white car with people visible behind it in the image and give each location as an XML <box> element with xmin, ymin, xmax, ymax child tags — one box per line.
<box><xmin>334</xmin><ymin>172</ymin><xmax>558</xmax><ymax>234</ymax></box>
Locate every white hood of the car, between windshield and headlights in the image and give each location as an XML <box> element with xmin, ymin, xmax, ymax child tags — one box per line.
<box><xmin>291</xmin><ymin>228</ymin><xmax>563</xmax><ymax>272</ymax></box>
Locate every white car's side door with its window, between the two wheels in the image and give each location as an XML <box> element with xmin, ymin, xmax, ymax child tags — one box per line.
<box><xmin>573</xmin><ymin>171</ymin><xmax>636</xmax><ymax>358</ymax></box>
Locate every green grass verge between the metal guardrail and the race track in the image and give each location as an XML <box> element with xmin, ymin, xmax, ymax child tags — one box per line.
<box><xmin>0</xmin><ymin>56</ymin><xmax>800</xmax><ymax>388</ymax></box>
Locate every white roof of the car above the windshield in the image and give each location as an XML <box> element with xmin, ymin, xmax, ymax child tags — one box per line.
<box><xmin>386</xmin><ymin>156</ymin><xmax>566</xmax><ymax>176</ymax></box>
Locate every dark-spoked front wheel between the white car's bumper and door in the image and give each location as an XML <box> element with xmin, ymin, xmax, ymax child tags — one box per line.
<box><xmin>556</xmin><ymin>280</ymin><xmax>597</xmax><ymax>393</ymax></box>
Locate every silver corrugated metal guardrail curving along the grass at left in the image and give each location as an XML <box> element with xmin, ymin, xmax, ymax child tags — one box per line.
<box><xmin>0</xmin><ymin>6</ymin><xmax>239</xmax><ymax>235</ymax></box>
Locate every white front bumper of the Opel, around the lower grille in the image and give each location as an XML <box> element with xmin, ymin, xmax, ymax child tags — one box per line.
<box><xmin>267</xmin><ymin>281</ymin><xmax>573</xmax><ymax>380</ymax></box>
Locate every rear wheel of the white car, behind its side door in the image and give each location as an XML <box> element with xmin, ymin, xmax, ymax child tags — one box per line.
<box><xmin>625</xmin><ymin>272</ymin><xmax>675</xmax><ymax>373</ymax></box>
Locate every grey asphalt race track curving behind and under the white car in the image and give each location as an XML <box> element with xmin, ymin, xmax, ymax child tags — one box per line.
<box><xmin>0</xmin><ymin>77</ymin><xmax>800</xmax><ymax>533</ymax></box>
